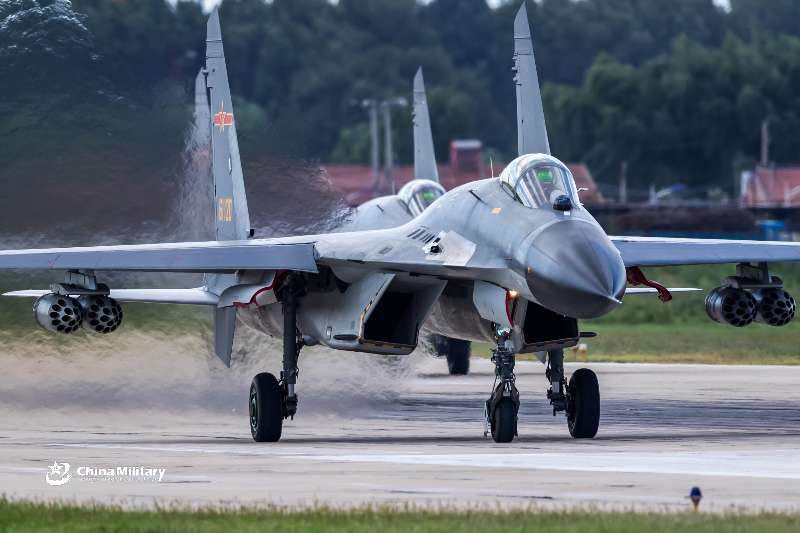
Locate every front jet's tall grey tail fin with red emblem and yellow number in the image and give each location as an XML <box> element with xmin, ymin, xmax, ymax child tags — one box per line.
<box><xmin>206</xmin><ymin>9</ymin><xmax>250</xmax><ymax>241</ymax></box>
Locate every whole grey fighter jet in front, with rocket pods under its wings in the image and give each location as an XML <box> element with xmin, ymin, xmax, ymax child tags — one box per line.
<box><xmin>0</xmin><ymin>5</ymin><xmax>800</xmax><ymax>442</ymax></box>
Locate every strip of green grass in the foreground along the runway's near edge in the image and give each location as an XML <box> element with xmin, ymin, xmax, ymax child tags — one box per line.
<box><xmin>0</xmin><ymin>500</ymin><xmax>800</xmax><ymax>533</ymax></box>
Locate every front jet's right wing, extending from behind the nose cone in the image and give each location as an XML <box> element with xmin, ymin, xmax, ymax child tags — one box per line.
<box><xmin>610</xmin><ymin>237</ymin><xmax>800</xmax><ymax>267</ymax></box>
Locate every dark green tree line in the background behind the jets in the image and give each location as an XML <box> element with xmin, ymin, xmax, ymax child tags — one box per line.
<box><xmin>0</xmin><ymin>0</ymin><xmax>800</xmax><ymax>194</ymax></box>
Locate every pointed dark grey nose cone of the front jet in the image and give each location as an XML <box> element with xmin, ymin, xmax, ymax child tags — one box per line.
<box><xmin>527</xmin><ymin>220</ymin><xmax>625</xmax><ymax>318</ymax></box>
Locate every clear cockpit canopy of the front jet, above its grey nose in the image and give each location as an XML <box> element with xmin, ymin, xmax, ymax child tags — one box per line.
<box><xmin>500</xmin><ymin>154</ymin><xmax>580</xmax><ymax>211</ymax></box>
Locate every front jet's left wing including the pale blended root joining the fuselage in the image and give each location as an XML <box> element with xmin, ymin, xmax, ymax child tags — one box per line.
<box><xmin>0</xmin><ymin>229</ymin><xmax>507</xmax><ymax>277</ymax></box>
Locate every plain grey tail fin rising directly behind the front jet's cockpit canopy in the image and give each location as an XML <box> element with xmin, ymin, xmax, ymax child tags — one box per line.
<box><xmin>514</xmin><ymin>2</ymin><xmax>550</xmax><ymax>155</ymax></box>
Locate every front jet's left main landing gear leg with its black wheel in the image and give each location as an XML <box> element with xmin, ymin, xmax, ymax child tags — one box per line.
<box><xmin>249</xmin><ymin>278</ymin><xmax>304</xmax><ymax>442</ymax></box>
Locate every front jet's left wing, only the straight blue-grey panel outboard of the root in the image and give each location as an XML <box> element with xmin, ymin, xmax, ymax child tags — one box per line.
<box><xmin>0</xmin><ymin>241</ymin><xmax>317</xmax><ymax>273</ymax></box>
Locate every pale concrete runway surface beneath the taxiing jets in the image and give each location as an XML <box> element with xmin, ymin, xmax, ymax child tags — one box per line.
<box><xmin>0</xmin><ymin>339</ymin><xmax>800</xmax><ymax>510</ymax></box>
